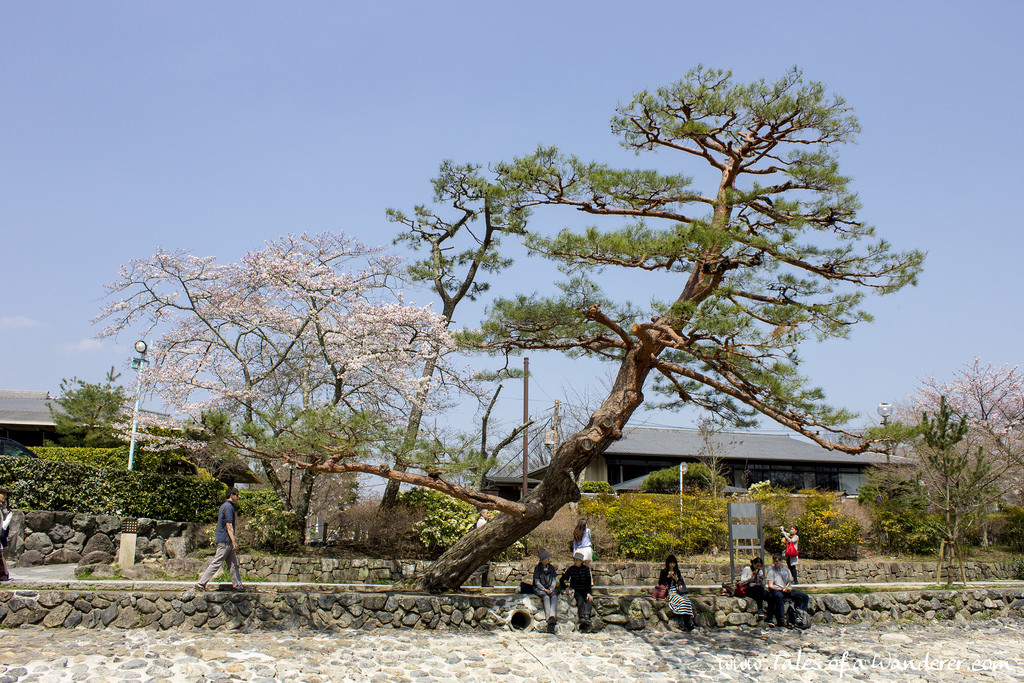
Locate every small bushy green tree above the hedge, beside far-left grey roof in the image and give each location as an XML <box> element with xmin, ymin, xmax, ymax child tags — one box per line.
<box><xmin>50</xmin><ymin>368</ymin><xmax>131</xmax><ymax>449</ymax></box>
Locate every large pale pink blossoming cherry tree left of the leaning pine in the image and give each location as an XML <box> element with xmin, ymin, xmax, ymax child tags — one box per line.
<box><xmin>96</xmin><ymin>233</ymin><xmax>528</xmax><ymax>520</ymax></box>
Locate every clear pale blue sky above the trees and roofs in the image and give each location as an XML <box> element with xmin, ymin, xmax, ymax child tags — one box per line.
<box><xmin>0</xmin><ymin>0</ymin><xmax>1024</xmax><ymax>438</ymax></box>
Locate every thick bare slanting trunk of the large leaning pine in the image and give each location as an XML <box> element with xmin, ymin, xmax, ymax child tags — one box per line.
<box><xmin>419</xmin><ymin>348</ymin><xmax>651</xmax><ymax>592</ymax></box>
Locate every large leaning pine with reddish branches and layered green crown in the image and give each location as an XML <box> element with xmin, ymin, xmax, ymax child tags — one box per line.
<box><xmin>411</xmin><ymin>68</ymin><xmax>923</xmax><ymax>590</ymax></box>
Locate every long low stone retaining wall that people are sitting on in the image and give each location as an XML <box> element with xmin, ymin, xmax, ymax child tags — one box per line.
<box><xmin>0</xmin><ymin>588</ymin><xmax>1024</xmax><ymax>632</ymax></box>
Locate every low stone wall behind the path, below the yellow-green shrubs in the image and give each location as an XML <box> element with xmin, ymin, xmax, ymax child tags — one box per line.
<box><xmin>234</xmin><ymin>556</ymin><xmax>1014</xmax><ymax>587</ymax></box>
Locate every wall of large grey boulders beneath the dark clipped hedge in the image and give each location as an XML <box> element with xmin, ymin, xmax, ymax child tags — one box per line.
<box><xmin>4</xmin><ymin>510</ymin><xmax>209</xmax><ymax>566</ymax></box>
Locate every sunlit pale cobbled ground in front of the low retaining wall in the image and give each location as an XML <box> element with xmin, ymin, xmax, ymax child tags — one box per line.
<box><xmin>0</xmin><ymin>618</ymin><xmax>1024</xmax><ymax>683</ymax></box>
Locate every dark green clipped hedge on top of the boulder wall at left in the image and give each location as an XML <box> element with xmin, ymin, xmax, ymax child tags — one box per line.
<box><xmin>0</xmin><ymin>457</ymin><xmax>224</xmax><ymax>522</ymax></box>
